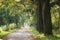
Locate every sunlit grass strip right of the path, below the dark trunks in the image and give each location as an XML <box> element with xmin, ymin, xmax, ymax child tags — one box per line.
<box><xmin>28</xmin><ymin>27</ymin><xmax>60</xmax><ymax>40</ymax></box>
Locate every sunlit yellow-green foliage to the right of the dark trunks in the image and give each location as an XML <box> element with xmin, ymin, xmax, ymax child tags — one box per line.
<box><xmin>51</xmin><ymin>5</ymin><xmax>60</xmax><ymax>33</ymax></box>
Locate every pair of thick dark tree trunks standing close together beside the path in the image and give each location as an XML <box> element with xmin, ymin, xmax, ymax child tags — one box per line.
<box><xmin>36</xmin><ymin>0</ymin><xmax>52</xmax><ymax>35</ymax></box>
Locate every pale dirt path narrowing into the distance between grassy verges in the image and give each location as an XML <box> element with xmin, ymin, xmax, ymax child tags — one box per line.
<box><xmin>3</xmin><ymin>28</ymin><xmax>34</xmax><ymax>40</ymax></box>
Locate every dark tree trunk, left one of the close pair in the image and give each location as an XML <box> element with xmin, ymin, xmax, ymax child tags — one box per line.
<box><xmin>36</xmin><ymin>0</ymin><xmax>43</xmax><ymax>32</ymax></box>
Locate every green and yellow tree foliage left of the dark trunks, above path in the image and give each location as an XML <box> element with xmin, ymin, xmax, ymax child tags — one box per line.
<box><xmin>0</xmin><ymin>0</ymin><xmax>36</xmax><ymax>28</ymax></box>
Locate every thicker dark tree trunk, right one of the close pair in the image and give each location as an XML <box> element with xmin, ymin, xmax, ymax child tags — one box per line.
<box><xmin>43</xmin><ymin>0</ymin><xmax>52</xmax><ymax>35</ymax></box>
